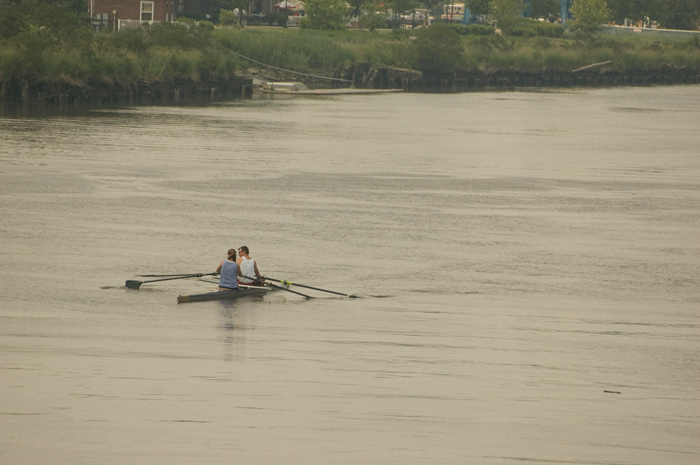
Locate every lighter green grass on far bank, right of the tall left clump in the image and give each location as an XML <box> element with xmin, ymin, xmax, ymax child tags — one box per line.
<box><xmin>213</xmin><ymin>28</ymin><xmax>700</xmax><ymax>74</ymax></box>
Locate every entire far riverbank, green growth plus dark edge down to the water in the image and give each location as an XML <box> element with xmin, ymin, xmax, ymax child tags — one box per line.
<box><xmin>0</xmin><ymin>23</ymin><xmax>700</xmax><ymax>106</ymax></box>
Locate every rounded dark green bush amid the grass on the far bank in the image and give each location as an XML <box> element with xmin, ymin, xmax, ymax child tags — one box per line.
<box><xmin>412</xmin><ymin>23</ymin><xmax>464</xmax><ymax>74</ymax></box>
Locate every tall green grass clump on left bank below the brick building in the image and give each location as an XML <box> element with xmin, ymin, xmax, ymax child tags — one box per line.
<box><xmin>0</xmin><ymin>24</ymin><xmax>239</xmax><ymax>86</ymax></box>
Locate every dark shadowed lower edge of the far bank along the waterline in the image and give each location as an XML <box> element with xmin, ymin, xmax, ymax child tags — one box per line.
<box><xmin>0</xmin><ymin>67</ymin><xmax>700</xmax><ymax>108</ymax></box>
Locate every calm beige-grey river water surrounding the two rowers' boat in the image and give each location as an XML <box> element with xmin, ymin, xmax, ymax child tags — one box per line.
<box><xmin>0</xmin><ymin>86</ymin><xmax>700</xmax><ymax>465</ymax></box>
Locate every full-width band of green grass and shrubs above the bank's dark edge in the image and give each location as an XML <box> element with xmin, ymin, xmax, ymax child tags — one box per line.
<box><xmin>0</xmin><ymin>23</ymin><xmax>700</xmax><ymax>99</ymax></box>
